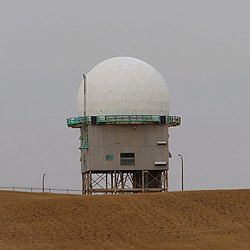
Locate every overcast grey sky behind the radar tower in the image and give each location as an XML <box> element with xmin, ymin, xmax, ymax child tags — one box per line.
<box><xmin>0</xmin><ymin>0</ymin><xmax>250</xmax><ymax>190</ymax></box>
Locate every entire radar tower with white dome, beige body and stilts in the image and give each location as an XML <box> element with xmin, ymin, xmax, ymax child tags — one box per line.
<box><xmin>67</xmin><ymin>57</ymin><xmax>181</xmax><ymax>194</ymax></box>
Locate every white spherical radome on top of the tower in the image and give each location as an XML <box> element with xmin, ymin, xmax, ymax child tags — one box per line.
<box><xmin>77</xmin><ymin>57</ymin><xmax>170</xmax><ymax>116</ymax></box>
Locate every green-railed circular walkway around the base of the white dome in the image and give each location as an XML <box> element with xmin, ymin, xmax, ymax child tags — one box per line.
<box><xmin>67</xmin><ymin>115</ymin><xmax>181</xmax><ymax>128</ymax></box>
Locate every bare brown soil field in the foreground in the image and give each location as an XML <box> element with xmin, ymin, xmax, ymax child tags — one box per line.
<box><xmin>0</xmin><ymin>189</ymin><xmax>250</xmax><ymax>249</ymax></box>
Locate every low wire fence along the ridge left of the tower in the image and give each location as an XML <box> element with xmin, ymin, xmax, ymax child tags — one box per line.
<box><xmin>0</xmin><ymin>186</ymin><xmax>82</xmax><ymax>195</ymax></box>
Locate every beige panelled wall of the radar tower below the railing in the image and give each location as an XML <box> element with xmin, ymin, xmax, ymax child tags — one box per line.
<box><xmin>82</xmin><ymin>125</ymin><xmax>168</xmax><ymax>172</ymax></box>
